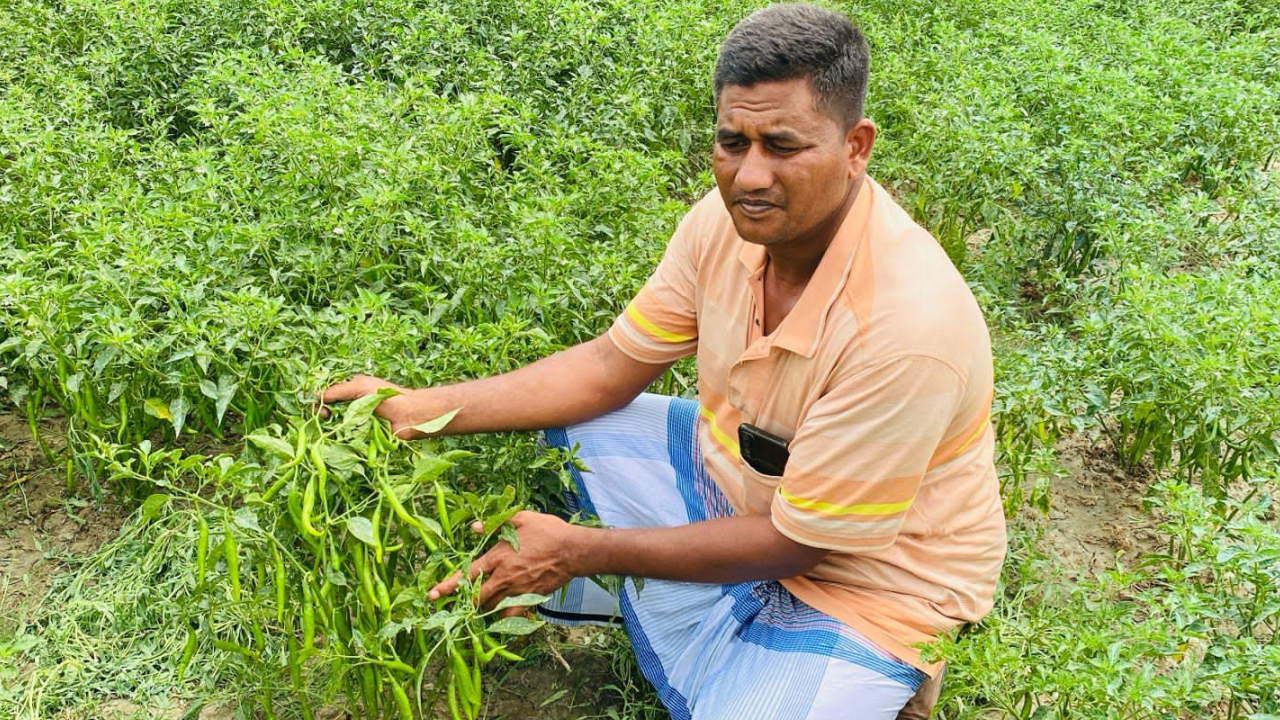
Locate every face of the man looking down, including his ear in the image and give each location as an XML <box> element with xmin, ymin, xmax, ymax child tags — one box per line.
<box><xmin>714</xmin><ymin>78</ymin><xmax>869</xmax><ymax>246</ymax></box>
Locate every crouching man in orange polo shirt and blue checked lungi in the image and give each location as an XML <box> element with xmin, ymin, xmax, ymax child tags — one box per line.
<box><xmin>324</xmin><ymin>5</ymin><xmax>1005</xmax><ymax>720</ymax></box>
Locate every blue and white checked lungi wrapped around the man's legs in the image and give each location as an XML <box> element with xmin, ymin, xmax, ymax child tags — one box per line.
<box><xmin>539</xmin><ymin>395</ymin><xmax>925</xmax><ymax>720</ymax></box>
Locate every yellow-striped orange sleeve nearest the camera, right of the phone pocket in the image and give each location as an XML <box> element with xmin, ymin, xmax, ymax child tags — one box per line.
<box><xmin>772</xmin><ymin>355</ymin><xmax>964</xmax><ymax>553</ymax></box>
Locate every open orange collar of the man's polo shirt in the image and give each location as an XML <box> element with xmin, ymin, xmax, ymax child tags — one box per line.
<box><xmin>739</xmin><ymin>176</ymin><xmax>878</xmax><ymax>357</ymax></box>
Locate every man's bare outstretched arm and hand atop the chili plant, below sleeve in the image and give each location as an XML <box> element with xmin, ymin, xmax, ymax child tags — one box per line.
<box><xmin>323</xmin><ymin>334</ymin><xmax>672</xmax><ymax>439</ymax></box>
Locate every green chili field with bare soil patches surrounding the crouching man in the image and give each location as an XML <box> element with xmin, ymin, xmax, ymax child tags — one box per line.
<box><xmin>0</xmin><ymin>0</ymin><xmax>1280</xmax><ymax>720</ymax></box>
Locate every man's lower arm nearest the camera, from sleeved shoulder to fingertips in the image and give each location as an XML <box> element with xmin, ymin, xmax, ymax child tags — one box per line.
<box><xmin>433</xmin><ymin>355</ymin><xmax>964</xmax><ymax>605</ymax></box>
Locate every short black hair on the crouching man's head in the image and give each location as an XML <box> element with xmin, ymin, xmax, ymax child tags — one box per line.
<box><xmin>714</xmin><ymin>3</ymin><xmax>870</xmax><ymax>124</ymax></box>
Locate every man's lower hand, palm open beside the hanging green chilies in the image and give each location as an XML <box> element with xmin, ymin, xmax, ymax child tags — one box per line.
<box><xmin>428</xmin><ymin>510</ymin><xmax>590</xmax><ymax>616</ymax></box>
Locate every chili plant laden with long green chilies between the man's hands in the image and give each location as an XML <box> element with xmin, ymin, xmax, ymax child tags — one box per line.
<box><xmin>94</xmin><ymin>391</ymin><xmax>545</xmax><ymax>720</ymax></box>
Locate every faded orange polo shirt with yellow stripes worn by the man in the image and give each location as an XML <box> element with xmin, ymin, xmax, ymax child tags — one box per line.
<box><xmin>609</xmin><ymin>177</ymin><xmax>1006</xmax><ymax>674</ymax></box>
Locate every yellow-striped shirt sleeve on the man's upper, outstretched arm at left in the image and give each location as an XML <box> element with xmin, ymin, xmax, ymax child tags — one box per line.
<box><xmin>609</xmin><ymin>213</ymin><xmax>698</xmax><ymax>365</ymax></box>
